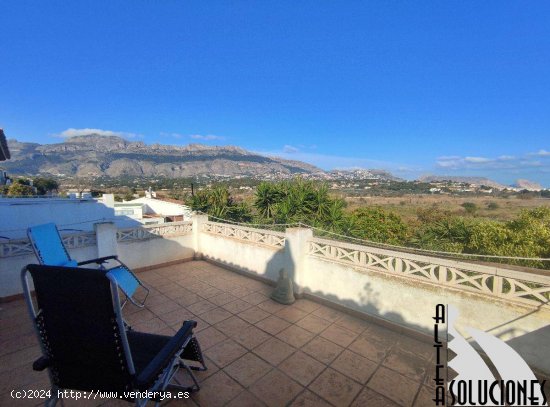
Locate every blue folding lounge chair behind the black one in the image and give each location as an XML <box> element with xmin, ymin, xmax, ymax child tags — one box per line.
<box><xmin>27</xmin><ymin>223</ymin><xmax>149</xmax><ymax>308</ymax></box>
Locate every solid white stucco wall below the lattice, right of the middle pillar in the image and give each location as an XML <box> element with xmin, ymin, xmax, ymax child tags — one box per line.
<box><xmin>303</xmin><ymin>256</ymin><xmax>550</xmax><ymax>372</ymax></box>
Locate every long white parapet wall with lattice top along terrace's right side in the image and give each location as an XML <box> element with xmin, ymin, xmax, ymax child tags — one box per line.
<box><xmin>196</xmin><ymin>223</ymin><xmax>550</xmax><ymax>374</ymax></box>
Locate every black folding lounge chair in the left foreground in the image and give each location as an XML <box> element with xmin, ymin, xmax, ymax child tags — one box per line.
<box><xmin>21</xmin><ymin>265</ymin><xmax>206</xmax><ymax>406</ymax></box>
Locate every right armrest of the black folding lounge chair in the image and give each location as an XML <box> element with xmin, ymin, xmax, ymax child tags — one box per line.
<box><xmin>136</xmin><ymin>321</ymin><xmax>197</xmax><ymax>389</ymax></box>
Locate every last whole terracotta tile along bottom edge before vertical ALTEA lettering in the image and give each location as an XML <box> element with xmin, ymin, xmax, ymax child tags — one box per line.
<box><xmin>367</xmin><ymin>367</ymin><xmax>420</xmax><ymax>406</ymax></box>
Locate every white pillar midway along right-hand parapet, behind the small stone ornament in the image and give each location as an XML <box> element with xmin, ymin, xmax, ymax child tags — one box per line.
<box><xmin>285</xmin><ymin>228</ymin><xmax>313</xmax><ymax>294</ymax></box>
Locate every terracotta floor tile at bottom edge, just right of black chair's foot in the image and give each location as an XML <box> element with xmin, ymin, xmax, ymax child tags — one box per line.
<box><xmin>191</xmin><ymin>370</ymin><xmax>243</xmax><ymax>407</ymax></box>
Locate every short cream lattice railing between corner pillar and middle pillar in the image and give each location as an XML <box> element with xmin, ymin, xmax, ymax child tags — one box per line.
<box><xmin>203</xmin><ymin>222</ymin><xmax>285</xmax><ymax>249</ymax></box>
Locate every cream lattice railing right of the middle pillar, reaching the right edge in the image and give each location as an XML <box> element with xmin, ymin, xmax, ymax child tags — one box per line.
<box><xmin>308</xmin><ymin>238</ymin><xmax>550</xmax><ymax>305</ymax></box>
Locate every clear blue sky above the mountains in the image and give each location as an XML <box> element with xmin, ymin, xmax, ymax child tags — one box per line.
<box><xmin>0</xmin><ymin>0</ymin><xmax>550</xmax><ymax>187</ymax></box>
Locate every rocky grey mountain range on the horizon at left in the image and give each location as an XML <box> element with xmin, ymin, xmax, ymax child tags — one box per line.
<box><xmin>2</xmin><ymin>134</ymin><xmax>323</xmax><ymax>178</ymax></box>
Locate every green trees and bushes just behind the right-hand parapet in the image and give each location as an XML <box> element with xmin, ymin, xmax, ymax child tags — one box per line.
<box><xmin>188</xmin><ymin>179</ymin><xmax>550</xmax><ymax>268</ymax></box>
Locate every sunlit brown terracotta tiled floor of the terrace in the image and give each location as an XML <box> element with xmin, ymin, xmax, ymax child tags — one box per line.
<box><xmin>0</xmin><ymin>261</ymin><xmax>440</xmax><ymax>407</ymax></box>
